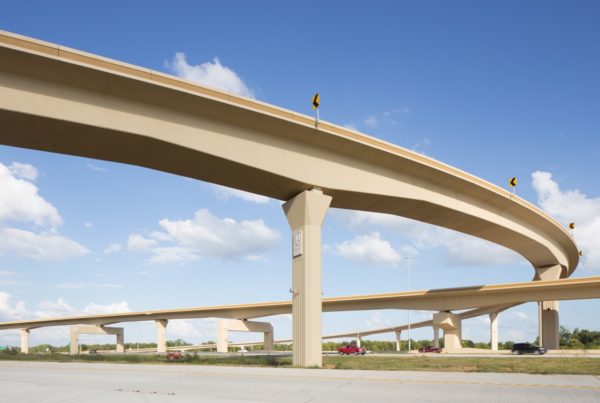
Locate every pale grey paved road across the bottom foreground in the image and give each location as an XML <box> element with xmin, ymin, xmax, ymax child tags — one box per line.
<box><xmin>0</xmin><ymin>361</ymin><xmax>600</xmax><ymax>403</ymax></box>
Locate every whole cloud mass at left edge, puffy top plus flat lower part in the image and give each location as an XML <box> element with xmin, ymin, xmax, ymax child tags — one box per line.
<box><xmin>0</xmin><ymin>162</ymin><xmax>89</xmax><ymax>260</ymax></box>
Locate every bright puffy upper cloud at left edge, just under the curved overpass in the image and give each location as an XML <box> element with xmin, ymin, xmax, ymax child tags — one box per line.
<box><xmin>0</xmin><ymin>163</ymin><xmax>62</xmax><ymax>228</ymax></box>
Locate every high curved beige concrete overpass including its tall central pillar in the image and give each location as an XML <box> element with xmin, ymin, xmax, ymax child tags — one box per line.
<box><xmin>0</xmin><ymin>31</ymin><xmax>579</xmax><ymax>365</ymax></box>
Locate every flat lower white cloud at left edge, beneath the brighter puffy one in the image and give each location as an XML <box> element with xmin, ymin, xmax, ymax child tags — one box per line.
<box><xmin>0</xmin><ymin>227</ymin><xmax>89</xmax><ymax>261</ymax></box>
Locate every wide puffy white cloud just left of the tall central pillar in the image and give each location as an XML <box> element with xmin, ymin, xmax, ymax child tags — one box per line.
<box><xmin>128</xmin><ymin>209</ymin><xmax>281</xmax><ymax>264</ymax></box>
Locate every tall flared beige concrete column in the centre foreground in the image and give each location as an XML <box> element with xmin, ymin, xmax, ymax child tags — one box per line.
<box><xmin>283</xmin><ymin>189</ymin><xmax>331</xmax><ymax>367</ymax></box>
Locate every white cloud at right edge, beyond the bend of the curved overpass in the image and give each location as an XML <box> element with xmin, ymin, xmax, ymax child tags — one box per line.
<box><xmin>531</xmin><ymin>171</ymin><xmax>600</xmax><ymax>270</ymax></box>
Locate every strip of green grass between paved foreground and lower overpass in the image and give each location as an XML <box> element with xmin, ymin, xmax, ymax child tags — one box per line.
<box><xmin>0</xmin><ymin>352</ymin><xmax>600</xmax><ymax>375</ymax></box>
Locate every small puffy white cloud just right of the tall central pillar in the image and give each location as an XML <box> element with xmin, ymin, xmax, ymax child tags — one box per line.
<box><xmin>335</xmin><ymin>232</ymin><xmax>402</xmax><ymax>266</ymax></box>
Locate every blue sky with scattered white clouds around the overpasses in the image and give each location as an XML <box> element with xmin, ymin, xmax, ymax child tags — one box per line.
<box><xmin>0</xmin><ymin>1</ymin><xmax>600</xmax><ymax>344</ymax></box>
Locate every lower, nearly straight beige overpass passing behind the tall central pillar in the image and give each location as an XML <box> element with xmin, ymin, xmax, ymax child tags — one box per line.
<box><xmin>0</xmin><ymin>276</ymin><xmax>600</xmax><ymax>351</ymax></box>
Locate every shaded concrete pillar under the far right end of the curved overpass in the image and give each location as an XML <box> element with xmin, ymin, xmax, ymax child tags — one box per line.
<box><xmin>534</xmin><ymin>265</ymin><xmax>563</xmax><ymax>350</ymax></box>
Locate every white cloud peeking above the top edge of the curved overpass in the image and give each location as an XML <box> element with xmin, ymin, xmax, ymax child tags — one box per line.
<box><xmin>166</xmin><ymin>52</ymin><xmax>254</xmax><ymax>98</ymax></box>
